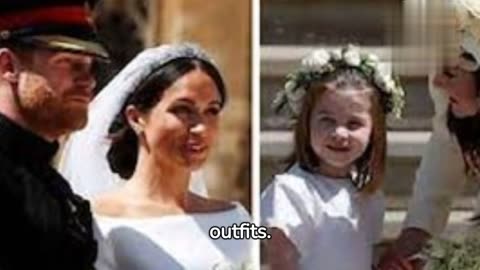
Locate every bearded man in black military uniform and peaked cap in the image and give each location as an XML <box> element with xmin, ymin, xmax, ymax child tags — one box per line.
<box><xmin>0</xmin><ymin>0</ymin><xmax>108</xmax><ymax>270</ymax></box>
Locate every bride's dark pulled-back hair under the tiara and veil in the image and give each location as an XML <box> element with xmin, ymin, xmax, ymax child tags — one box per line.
<box><xmin>107</xmin><ymin>58</ymin><xmax>227</xmax><ymax>179</ymax></box>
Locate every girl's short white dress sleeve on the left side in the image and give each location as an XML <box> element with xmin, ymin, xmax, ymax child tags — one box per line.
<box><xmin>261</xmin><ymin>176</ymin><xmax>315</xmax><ymax>254</ymax></box>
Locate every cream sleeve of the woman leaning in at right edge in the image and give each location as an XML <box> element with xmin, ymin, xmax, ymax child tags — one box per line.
<box><xmin>404</xmin><ymin>83</ymin><xmax>467</xmax><ymax>235</ymax></box>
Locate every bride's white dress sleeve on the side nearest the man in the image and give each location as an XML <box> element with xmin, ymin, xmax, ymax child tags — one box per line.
<box><xmin>94</xmin><ymin>222</ymin><xmax>117</xmax><ymax>270</ymax></box>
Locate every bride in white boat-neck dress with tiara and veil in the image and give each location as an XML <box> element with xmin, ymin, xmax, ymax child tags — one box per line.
<box><xmin>61</xmin><ymin>44</ymin><xmax>250</xmax><ymax>270</ymax></box>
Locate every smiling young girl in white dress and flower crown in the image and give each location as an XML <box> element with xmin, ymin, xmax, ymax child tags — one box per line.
<box><xmin>261</xmin><ymin>46</ymin><xmax>403</xmax><ymax>270</ymax></box>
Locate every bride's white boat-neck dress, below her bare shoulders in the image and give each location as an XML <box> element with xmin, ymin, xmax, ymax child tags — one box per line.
<box><xmin>95</xmin><ymin>204</ymin><xmax>250</xmax><ymax>270</ymax></box>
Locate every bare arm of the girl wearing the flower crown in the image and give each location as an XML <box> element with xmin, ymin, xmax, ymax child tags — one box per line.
<box><xmin>266</xmin><ymin>228</ymin><xmax>300</xmax><ymax>270</ymax></box>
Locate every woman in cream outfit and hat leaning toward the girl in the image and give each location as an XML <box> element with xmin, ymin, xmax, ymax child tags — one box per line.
<box><xmin>380</xmin><ymin>0</ymin><xmax>480</xmax><ymax>270</ymax></box>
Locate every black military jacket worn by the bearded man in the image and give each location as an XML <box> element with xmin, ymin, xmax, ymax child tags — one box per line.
<box><xmin>0</xmin><ymin>114</ymin><xmax>97</xmax><ymax>270</ymax></box>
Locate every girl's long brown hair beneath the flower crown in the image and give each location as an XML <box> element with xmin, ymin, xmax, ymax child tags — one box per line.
<box><xmin>288</xmin><ymin>68</ymin><xmax>386</xmax><ymax>194</ymax></box>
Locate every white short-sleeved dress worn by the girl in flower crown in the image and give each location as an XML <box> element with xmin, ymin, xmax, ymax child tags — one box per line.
<box><xmin>261</xmin><ymin>165</ymin><xmax>384</xmax><ymax>270</ymax></box>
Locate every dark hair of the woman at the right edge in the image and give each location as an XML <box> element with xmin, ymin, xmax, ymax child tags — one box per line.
<box><xmin>447</xmin><ymin>52</ymin><xmax>480</xmax><ymax>172</ymax></box>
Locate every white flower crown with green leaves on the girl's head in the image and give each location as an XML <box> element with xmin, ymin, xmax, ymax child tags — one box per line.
<box><xmin>272</xmin><ymin>45</ymin><xmax>405</xmax><ymax>119</ymax></box>
